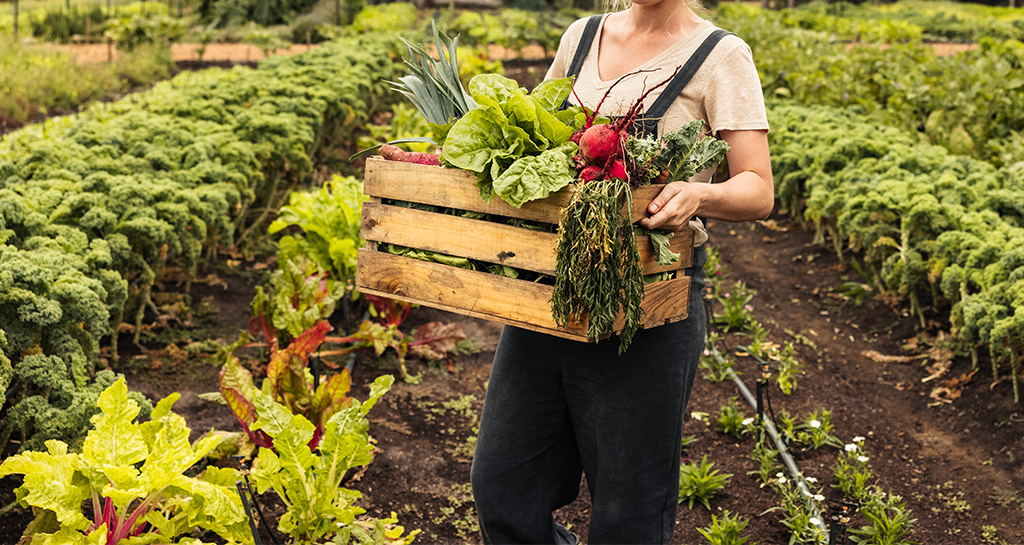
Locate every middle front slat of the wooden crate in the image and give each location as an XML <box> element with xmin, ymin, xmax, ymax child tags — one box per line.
<box><xmin>359</xmin><ymin>203</ymin><xmax>557</xmax><ymax>276</ymax></box>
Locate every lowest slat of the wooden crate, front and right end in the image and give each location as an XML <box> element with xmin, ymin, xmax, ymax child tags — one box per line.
<box><xmin>355</xmin><ymin>249</ymin><xmax>690</xmax><ymax>341</ymax></box>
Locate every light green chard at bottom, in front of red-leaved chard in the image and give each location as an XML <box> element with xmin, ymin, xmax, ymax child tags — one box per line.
<box><xmin>252</xmin><ymin>375</ymin><xmax>419</xmax><ymax>544</ymax></box>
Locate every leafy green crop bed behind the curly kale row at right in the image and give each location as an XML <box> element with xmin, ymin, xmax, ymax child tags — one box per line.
<box><xmin>716</xmin><ymin>4</ymin><xmax>1024</xmax><ymax>166</ymax></box>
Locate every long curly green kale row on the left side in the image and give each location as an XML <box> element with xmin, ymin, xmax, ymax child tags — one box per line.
<box><xmin>0</xmin><ymin>37</ymin><xmax>399</xmax><ymax>449</ymax></box>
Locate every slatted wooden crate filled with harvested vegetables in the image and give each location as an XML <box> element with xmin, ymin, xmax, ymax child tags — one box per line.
<box><xmin>355</xmin><ymin>158</ymin><xmax>693</xmax><ymax>341</ymax></box>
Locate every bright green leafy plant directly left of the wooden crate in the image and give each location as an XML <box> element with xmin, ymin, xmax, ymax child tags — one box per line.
<box><xmin>267</xmin><ymin>175</ymin><xmax>368</xmax><ymax>284</ymax></box>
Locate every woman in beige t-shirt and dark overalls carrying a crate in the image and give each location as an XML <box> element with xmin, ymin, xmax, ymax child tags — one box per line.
<box><xmin>472</xmin><ymin>0</ymin><xmax>774</xmax><ymax>544</ymax></box>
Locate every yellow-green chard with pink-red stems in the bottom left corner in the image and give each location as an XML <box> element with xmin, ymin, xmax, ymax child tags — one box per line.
<box><xmin>0</xmin><ymin>379</ymin><xmax>249</xmax><ymax>543</ymax></box>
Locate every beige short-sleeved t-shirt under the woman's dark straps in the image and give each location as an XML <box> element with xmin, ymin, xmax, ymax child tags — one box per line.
<box><xmin>546</xmin><ymin>15</ymin><xmax>768</xmax><ymax>246</ymax></box>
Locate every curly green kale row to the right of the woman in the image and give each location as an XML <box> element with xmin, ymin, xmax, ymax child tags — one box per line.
<box><xmin>769</xmin><ymin>103</ymin><xmax>1024</xmax><ymax>400</ymax></box>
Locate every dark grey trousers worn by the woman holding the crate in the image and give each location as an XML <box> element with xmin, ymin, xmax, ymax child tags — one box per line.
<box><xmin>472</xmin><ymin>248</ymin><xmax>707</xmax><ymax>545</ymax></box>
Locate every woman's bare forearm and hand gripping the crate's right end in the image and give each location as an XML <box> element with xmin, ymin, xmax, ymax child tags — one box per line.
<box><xmin>639</xmin><ymin>130</ymin><xmax>775</xmax><ymax>230</ymax></box>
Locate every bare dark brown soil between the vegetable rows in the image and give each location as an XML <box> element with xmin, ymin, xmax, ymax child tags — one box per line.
<box><xmin>0</xmin><ymin>51</ymin><xmax>1024</xmax><ymax>544</ymax></box>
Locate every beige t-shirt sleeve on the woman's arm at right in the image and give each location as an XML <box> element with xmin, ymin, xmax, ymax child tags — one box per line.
<box><xmin>701</xmin><ymin>39</ymin><xmax>768</xmax><ymax>134</ymax></box>
